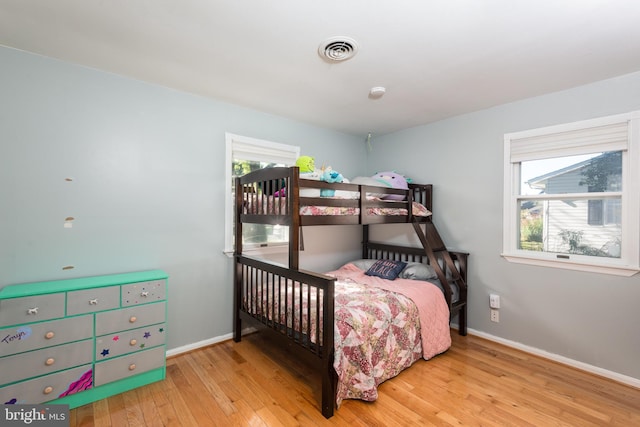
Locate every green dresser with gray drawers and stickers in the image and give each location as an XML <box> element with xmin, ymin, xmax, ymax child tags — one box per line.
<box><xmin>0</xmin><ymin>270</ymin><xmax>168</xmax><ymax>408</ymax></box>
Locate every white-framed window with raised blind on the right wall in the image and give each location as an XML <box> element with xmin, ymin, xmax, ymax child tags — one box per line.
<box><xmin>503</xmin><ymin>112</ymin><xmax>640</xmax><ymax>276</ymax></box>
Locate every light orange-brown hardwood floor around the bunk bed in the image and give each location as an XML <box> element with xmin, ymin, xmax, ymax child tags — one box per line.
<box><xmin>70</xmin><ymin>331</ymin><xmax>640</xmax><ymax>427</ymax></box>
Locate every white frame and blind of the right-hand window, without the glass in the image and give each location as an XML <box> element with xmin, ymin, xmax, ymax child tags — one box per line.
<box><xmin>501</xmin><ymin>111</ymin><xmax>640</xmax><ymax>276</ymax></box>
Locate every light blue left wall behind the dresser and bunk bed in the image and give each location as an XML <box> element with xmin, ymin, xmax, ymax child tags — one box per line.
<box><xmin>0</xmin><ymin>48</ymin><xmax>365</xmax><ymax>348</ymax></box>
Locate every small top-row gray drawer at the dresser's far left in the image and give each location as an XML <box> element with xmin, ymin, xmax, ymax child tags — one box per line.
<box><xmin>0</xmin><ymin>293</ymin><xmax>64</xmax><ymax>327</ymax></box>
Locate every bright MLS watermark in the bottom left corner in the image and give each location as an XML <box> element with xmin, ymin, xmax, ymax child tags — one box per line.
<box><xmin>0</xmin><ymin>405</ymin><xmax>69</xmax><ymax>427</ymax></box>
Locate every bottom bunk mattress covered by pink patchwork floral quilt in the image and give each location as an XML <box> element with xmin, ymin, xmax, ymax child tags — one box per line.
<box><xmin>244</xmin><ymin>263</ymin><xmax>451</xmax><ymax>406</ymax></box>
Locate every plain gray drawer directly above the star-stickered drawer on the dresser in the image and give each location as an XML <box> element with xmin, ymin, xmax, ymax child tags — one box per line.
<box><xmin>96</xmin><ymin>302</ymin><xmax>166</xmax><ymax>335</ymax></box>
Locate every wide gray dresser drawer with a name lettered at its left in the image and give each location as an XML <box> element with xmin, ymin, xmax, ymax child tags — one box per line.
<box><xmin>0</xmin><ymin>315</ymin><xmax>93</xmax><ymax>358</ymax></box>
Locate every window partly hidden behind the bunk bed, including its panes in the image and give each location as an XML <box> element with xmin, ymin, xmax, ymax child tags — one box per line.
<box><xmin>224</xmin><ymin>133</ymin><xmax>300</xmax><ymax>254</ymax></box>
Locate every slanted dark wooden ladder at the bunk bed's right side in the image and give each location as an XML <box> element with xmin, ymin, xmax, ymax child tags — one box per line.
<box><xmin>411</xmin><ymin>217</ymin><xmax>467</xmax><ymax>335</ymax></box>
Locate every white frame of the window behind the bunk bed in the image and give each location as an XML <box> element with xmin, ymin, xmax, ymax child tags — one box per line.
<box><xmin>224</xmin><ymin>132</ymin><xmax>300</xmax><ymax>256</ymax></box>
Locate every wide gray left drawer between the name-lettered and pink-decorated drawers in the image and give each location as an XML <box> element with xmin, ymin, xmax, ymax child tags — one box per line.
<box><xmin>0</xmin><ymin>339</ymin><xmax>93</xmax><ymax>384</ymax></box>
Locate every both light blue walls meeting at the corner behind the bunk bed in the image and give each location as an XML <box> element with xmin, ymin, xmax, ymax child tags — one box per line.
<box><xmin>0</xmin><ymin>43</ymin><xmax>640</xmax><ymax>378</ymax></box>
